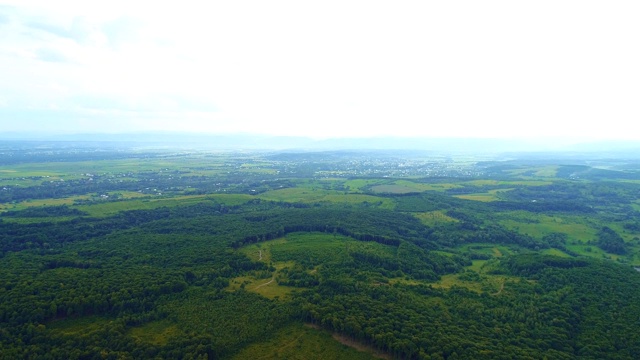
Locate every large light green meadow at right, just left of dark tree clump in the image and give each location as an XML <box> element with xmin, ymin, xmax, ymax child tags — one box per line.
<box><xmin>499</xmin><ymin>214</ymin><xmax>598</xmax><ymax>241</ymax></box>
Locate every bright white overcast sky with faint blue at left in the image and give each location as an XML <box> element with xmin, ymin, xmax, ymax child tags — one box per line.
<box><xmin>0</xmin><ymin>0</ymin><xmax>640</xmax><ymax>140</ymax></box>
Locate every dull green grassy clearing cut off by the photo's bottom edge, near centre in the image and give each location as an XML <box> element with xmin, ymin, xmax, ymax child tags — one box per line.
<box><xmin>232</xmin><ymin>323</ymin><xmax>380</xmax><ymax>360</ymax></box>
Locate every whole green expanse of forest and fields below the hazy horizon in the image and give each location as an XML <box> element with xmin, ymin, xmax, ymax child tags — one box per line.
<box><xmin>0</xmin><ymin>144</ymin><xmax>640</xmax><ymax>359</ymax></box>
